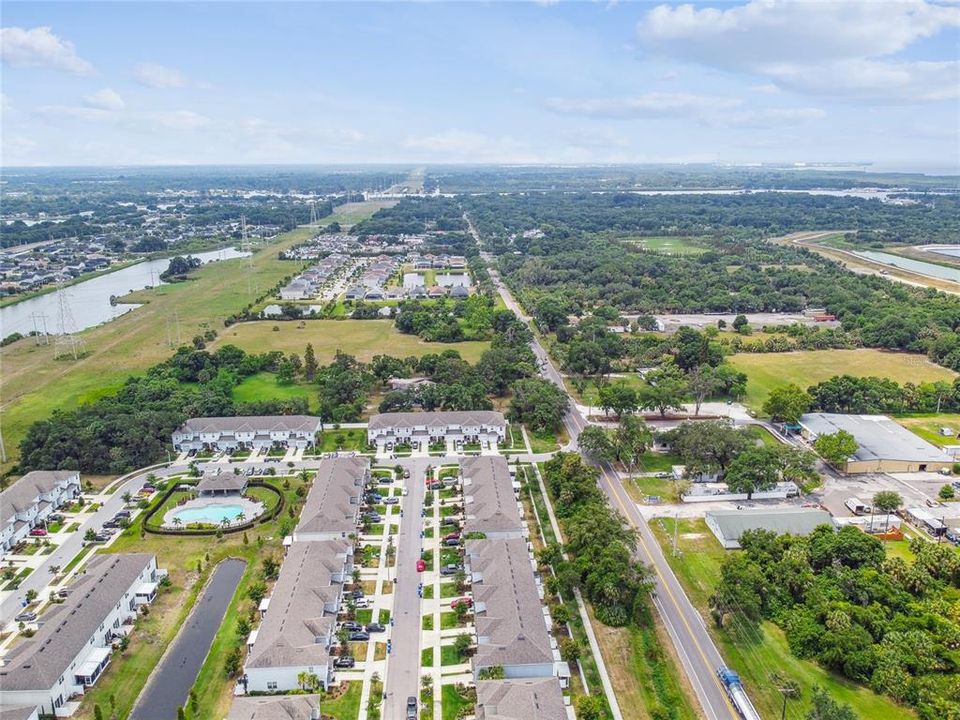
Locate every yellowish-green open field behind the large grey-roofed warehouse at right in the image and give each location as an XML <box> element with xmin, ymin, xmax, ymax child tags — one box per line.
<box><xmin>728</xmin><ymin>348</ymin><xmax>956</xmax><ymax>410</ymax></box>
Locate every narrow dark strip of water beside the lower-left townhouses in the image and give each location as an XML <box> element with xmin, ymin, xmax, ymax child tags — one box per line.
<box><xmin>130</xmin><ymin>558</ymin><xmax>247</xmax><ymax>720</ymax></box>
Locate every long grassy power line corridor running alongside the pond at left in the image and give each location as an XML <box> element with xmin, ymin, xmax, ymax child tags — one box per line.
<box><xmin>0</xmin><ymin>228</ymin><xmax>313</xmax><ymax>469</ymax></box>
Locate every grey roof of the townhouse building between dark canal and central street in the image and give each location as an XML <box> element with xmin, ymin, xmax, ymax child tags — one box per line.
<box><xmin>247</xmin><ymin>540</ymin><xmax>352</xmax><ymax>667</ymax></box>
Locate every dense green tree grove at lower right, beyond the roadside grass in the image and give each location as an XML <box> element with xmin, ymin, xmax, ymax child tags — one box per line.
<box><xmin>710</xmin><ymin>525</ymin><xmax>960</xmax><ymax>720</ymax></box>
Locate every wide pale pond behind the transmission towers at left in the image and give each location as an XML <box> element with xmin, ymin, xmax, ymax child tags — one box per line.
<box><xmin>0</xmin><ymin>248</ymin><xmax>250</xmax><ymax>337</ymax></box>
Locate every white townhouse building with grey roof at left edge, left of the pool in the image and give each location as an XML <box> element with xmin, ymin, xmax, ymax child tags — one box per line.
<box><xmin>0</xmin><ymin>470</ymin><xmax>80</xmax><ymax>554</ymax></box>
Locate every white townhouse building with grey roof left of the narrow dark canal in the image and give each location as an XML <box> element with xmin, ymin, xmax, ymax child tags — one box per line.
<box><xmin>0</xmin><ymin>553</ymin><xmax>163</xmax><ymax>714</ymax></box>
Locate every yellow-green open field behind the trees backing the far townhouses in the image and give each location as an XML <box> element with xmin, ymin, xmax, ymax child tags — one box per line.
<box><xmin>213</xmin><ymin>320</ymin><xmax>490</xmax><ymax>365</ymax></box>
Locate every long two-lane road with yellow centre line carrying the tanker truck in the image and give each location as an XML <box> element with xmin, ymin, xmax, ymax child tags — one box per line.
<box><xmin>480</xmin><ymin>246</ymin><xmax>739</xmax><ymax>720</ymax></box>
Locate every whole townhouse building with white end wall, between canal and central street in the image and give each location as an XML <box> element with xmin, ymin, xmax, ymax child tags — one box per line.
<box><xmin>244</xmin><ymin>540</ymin><xmax>353</xmax><ymax>692</ymax></box>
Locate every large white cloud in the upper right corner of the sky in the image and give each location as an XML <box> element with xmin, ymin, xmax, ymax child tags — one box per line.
<box><xmin>637</xmin><ymin>0</ymin><xmax>960</xmax><ymax>103</ymax></box>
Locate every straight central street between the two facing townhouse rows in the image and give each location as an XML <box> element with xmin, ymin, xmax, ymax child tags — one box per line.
<box><xmin>383</xmin><ymin>458</ymin><xmax>428</xmax><ymax>720</ymax></box>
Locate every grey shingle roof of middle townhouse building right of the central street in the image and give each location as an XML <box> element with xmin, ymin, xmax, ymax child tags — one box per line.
<box><xmin>466</xmin><ymin>538</ymin><xmax>554</xmax><ymax>668</ymax></box>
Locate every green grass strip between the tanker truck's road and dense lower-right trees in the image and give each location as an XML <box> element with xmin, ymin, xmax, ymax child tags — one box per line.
<box><xmin>650</xmin><ymin>518</ymin><xmax>916</xmax><ymax>720</ymax></box>
